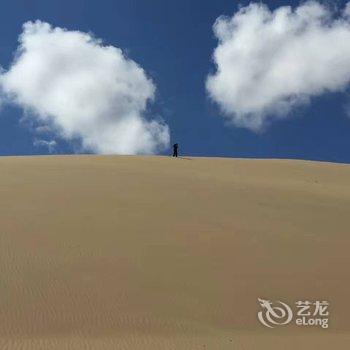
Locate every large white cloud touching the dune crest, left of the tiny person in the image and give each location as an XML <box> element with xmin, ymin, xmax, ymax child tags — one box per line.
<box><xmin>1</xmin><ymin>21</ymin><xmax>169</xmax><ymax>154</ymax></box>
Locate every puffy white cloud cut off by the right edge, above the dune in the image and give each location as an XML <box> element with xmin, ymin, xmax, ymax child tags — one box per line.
<box><xmin>206</xmin><ymin>1</ymin><xmax>350</xmax><ymax>131</ymax></box>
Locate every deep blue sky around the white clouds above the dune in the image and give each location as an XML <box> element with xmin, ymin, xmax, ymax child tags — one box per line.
<box><xmin>0</xmin><ymin>0</ymin><xmax>350</xmax><ymax>163</ymax></box>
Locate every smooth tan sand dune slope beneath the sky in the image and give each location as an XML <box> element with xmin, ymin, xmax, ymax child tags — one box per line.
<box><xmin>0</xmin><ymin>156</ymin><xmax>350</xmax><ymax>350</ymax></box>
